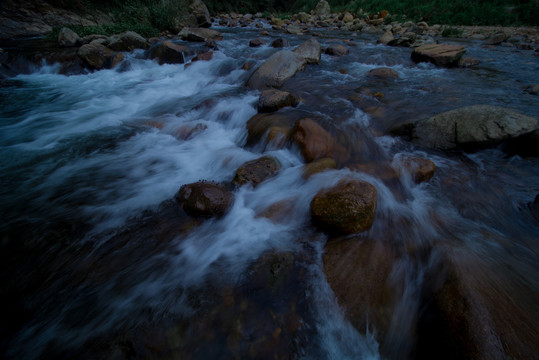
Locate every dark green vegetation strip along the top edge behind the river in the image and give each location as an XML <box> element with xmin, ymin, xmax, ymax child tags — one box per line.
<box><xmin>49</xmin><ymin>0</ymin><xmax>539</xmax><ymax>26</ymax></box>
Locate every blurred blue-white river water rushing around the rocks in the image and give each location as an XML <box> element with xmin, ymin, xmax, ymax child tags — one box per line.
<box><xmin>0</xmin><ymin>21</ymin><xmax>539</xmax><ymax>359</ymax></box>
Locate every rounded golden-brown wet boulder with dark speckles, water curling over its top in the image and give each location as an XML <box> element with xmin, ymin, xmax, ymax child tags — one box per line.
<box><xmin>311</xmin><ymin>179</ymin><xmax>376</xmax><ymax>235</ymax></box>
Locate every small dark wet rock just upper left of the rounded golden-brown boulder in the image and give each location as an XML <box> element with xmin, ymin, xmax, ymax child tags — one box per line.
<box><xmin>232</xmin><ymin>156</ymin><xmax>281</xmax><ymax>186</ymax></box>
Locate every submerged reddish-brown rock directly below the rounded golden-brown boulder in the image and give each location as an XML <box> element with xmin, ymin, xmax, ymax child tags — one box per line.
<box><xmin>323</xmin><ymin>237</ymin><xmax>397</xmax><ymax>351</ymax></box>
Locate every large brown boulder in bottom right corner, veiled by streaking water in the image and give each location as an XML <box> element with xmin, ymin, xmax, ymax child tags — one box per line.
<box><xmin>416</xmin><ymin>248</ymin><xmax>539</xmax><ymax>360</ymax></box>
